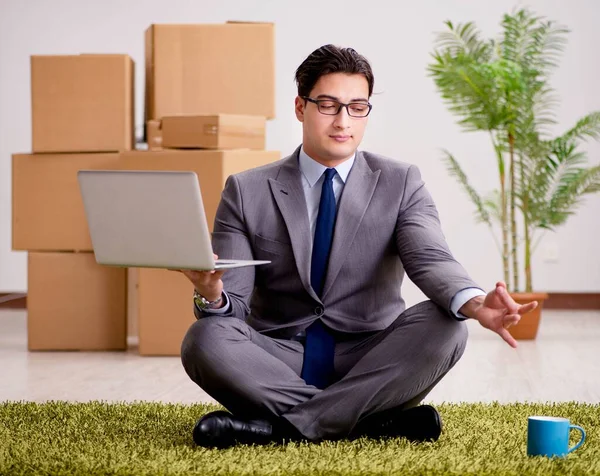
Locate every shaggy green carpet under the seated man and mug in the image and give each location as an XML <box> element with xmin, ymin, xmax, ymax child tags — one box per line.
<box><xmin>0</xmin><ymin>402</ymin><xmax>600</xmax><ymax>476</ymax></box>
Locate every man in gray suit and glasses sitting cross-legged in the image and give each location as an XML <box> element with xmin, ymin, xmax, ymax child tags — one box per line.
<box><xmin>176</xmin><ymin>45</ymin><xmax>537</xmax><ymax>448</ymax></box>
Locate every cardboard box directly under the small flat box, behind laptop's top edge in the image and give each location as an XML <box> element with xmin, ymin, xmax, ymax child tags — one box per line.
<box><xmin>117</xmin><ymin>149</ymin><xmax>280</xmax><ymax>232</ymax></box>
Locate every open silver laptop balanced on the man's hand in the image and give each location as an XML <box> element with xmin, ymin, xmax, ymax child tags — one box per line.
<box><xmin>77</xmin><ymin>170</ymin><xmax>270</xmax><ymax>270</ymax></box>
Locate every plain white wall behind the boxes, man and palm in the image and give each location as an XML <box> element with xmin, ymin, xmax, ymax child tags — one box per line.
<box><xmin>0</xmin><ymin>0</ymin><xmax>600</xmax><ymax>303</ymax></box>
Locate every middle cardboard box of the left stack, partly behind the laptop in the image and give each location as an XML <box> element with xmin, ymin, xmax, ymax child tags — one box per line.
<box><xmin>12</xmin><ymin>153</ymin><xmax>119</xmax><ymax>251</ymax></box>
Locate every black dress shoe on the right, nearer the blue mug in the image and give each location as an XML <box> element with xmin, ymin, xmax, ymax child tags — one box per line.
<box><xmin>351</xmin><ymin>405</ymin><xmax>442</xmax><ymax>443</ymax></box>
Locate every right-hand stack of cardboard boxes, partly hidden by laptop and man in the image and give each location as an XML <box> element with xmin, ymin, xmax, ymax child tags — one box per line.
<box><xmin>131</xmin><ymin>22</ymin><xmax>280</xmax><ymax>355</ymax></box>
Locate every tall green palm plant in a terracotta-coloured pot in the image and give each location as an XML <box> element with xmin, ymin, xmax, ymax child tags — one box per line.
<box><xmin>428</xmin><ymin>9</ymin><xmax>600</xmax><ymax>339</ymax></box>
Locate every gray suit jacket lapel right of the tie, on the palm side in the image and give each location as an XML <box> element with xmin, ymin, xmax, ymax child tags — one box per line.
<box><xmin>324</xmin><ymin>152</ymin><xmax>381</xmax><ymax>298</ymax></box>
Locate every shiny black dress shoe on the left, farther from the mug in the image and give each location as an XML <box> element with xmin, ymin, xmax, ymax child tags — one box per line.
<box><xmin>193</xmin><ymin>411</ymin><xmax>275</xmax><ymax>448</ymax></box>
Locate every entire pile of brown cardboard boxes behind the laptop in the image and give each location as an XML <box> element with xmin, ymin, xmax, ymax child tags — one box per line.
<box><xmin>13</xmin><ymin>22</ymin><xmax>279</xmax><ymax>355</ymax></box>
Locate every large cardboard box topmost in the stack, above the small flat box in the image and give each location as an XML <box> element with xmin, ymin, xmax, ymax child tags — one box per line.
<box><xmin>145</xmin><ymin>23</ymin><xmax>275</xmax><ymax>121</ymax></box>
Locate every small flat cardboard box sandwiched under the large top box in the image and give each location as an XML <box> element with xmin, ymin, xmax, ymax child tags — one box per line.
<box><xmin>161</xmin><ymin>114</ymin><xmax>266</xmax><ymax>150</ymax></box>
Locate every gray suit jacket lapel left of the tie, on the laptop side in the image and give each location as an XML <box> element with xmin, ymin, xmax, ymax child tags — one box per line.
<box><xmin>269</xmin><ymin>147</ymin><xmax>318</xmax><ymax>299</ymax></box>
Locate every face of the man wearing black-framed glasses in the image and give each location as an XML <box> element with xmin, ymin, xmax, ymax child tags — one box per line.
<box><xmin>296</xmin><ymin>73</ymin><xmax>369</xmax><ymax>167</ymax></box>
